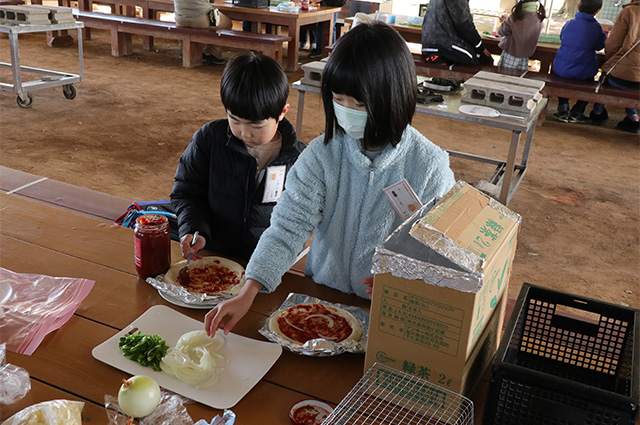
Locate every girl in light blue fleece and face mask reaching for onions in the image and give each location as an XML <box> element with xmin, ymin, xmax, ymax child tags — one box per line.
<box><xmin>205</xmin><ymin>23</ymin><xmax>455</xmax><ymax>335</ymax></box>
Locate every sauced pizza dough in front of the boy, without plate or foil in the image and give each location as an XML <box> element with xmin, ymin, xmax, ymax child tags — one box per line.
<box><xmin>164</xmin><ymin>257</ymin><xmax>245</xmax><ymax>295</ymax></box>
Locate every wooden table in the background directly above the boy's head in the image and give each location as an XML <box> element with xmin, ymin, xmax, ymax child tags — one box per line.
<box><xmin>214</xmin><ymin>2</ymin><xmax>340</xmax><ymax>71</ymax></box>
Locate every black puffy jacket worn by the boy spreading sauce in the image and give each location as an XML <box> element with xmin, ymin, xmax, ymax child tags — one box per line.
<box><xmin>171</xmin><ymin>118</ymin><xmax>306</xmax><ymax>259</ymax></box>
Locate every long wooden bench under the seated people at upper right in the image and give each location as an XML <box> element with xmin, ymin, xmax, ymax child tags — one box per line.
<box><xmin>414</xmin><ymin>55</ymin><xmax>640</xmax><ymax>109</ymax></box>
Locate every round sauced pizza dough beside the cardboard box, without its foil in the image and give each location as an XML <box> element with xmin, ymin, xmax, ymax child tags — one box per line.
<box><xmin>268</xmin><ymin>303</ymin><xmax>362</xmax><ymax>345</ymax></box>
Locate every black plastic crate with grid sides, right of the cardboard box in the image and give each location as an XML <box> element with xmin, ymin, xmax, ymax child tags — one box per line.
<box><xmin>483</xmin><ymin>282</ymin><xmax>640</xmax><ymax>425</ymax></box>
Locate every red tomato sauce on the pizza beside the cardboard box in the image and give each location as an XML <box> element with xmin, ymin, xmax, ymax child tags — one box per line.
<box><xmin>278</xmin><ymin>304</ymin><xmax>353</xmax><ymax>344</ymax></box>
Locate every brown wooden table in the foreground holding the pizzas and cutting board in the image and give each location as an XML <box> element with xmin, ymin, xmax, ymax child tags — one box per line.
<box><xmin>0</xmin><ymin>194</ymin><xmax>369</xmax><ymax>425</ymax></box>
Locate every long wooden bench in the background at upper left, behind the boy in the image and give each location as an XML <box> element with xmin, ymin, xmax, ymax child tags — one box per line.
<box><xmin>73</xmin><ymin>9</ymin><xmax>290</xmax><ymax>68</ymax></box>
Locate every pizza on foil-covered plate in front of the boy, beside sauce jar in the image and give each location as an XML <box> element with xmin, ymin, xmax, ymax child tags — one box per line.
<box><xmin>147</xmin><ymin>257</ymin><xmax>245</xmax><ymax>308</ymax></box>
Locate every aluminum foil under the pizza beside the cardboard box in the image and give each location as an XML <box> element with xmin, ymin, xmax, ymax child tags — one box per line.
<box><xmin>258</xmin><ymin>292</ymin><xmax>369</xmax><ymax>357</ymax></box>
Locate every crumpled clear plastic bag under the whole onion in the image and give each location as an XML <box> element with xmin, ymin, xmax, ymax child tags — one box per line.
<box><xmin>104</xmin><ymin>390</ymin><xmax>193</xmax><ymax>425</ymax></box>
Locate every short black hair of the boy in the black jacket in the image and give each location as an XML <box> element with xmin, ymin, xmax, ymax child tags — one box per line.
<box><xmin>220</xmin><ymin>53</ymin><xmax>289</xmax><ymax>121</ymax></box>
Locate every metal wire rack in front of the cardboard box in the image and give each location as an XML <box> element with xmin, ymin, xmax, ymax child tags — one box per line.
<box><xmin>322</xmin><ymin>363</ymin><xmax>473</xmax><ymax>425</ymax></box>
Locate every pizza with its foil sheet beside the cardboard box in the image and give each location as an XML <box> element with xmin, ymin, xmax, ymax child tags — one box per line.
<box><xmin>260</xmin><ymin>293</ymin><xmax>369</xmax><ymax>356</ymax></box>
